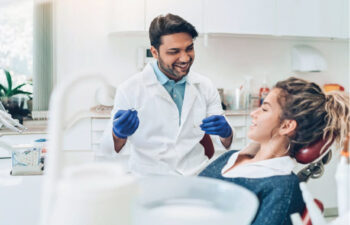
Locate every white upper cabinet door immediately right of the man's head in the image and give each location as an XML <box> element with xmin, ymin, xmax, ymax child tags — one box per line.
<box><xmin>204</xmin><ymin>0</ymin><xmax>276</xmax><ymax>35</ymax></box>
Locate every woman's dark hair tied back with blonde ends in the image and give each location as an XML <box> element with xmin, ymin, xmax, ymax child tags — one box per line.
<box><xmin>275</xmin><ymin>77</ymin><xmax>350</xmax><ymax>156</ymax></box>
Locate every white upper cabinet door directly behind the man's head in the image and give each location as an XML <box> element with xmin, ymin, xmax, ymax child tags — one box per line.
<box><xmin>146</xmin><ymin>0</ymin><xmax>203</xmax><ymax>33</ymax></box>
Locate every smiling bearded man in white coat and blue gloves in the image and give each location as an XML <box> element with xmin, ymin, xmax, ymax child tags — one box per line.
<box><xmin>102</xmin><ymin>14</ymin><xmax>233</xmax><ymax>175</ymax></box>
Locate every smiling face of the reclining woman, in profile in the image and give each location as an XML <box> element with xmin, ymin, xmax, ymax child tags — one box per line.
<box><xmin>248</xmin><ymin>88</ymin><xmax>282</xmax><ymax>143</ymax></box>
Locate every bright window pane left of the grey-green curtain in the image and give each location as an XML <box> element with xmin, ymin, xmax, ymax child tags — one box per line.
<box><xmin>0</xmin><ymin>0</ymin><xmax>33</xmax><ymax>85</ymax></box>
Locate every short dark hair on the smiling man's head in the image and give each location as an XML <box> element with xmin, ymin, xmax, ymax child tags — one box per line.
<box><xmin>149</xmin><ymin>13</ymin><xmax>198</xmax><ymax>49</ymax></box>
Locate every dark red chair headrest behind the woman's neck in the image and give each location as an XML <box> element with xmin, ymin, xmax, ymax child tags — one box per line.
<box><xmin>295</xmin><ymin>138</ymin><xmax>333</xmax><ymax>164</ymax></box>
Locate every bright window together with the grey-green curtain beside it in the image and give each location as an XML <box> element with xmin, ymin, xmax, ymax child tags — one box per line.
<box><xmin>0</xmin><ymin>0</ymin><xmax>53</xmax><ymax>118</ymax></box>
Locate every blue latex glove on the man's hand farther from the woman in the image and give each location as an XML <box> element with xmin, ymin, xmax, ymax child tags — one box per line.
<box><xmin>113</xmin><ymin>109</ymin><xmax>140</xmax><ymax>139</ymax></box>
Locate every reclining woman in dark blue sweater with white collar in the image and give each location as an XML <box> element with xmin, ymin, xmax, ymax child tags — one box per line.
<box><xmin>200</xmin><ymin>77</ymin><xmax>350</xmax><ymax>225</ymax></box>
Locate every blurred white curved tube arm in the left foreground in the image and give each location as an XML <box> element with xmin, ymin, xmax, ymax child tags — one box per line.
<box><xmin>40</xmin><ymin>75</ymin><xmax>109</xmax><ymax>225</ymax></box>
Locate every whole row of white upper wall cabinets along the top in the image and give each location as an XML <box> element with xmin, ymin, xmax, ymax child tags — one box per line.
<box><xmin>109</xmin><ymin>0</ymin><xmax>349</xmax><ymax>38</ymax></box>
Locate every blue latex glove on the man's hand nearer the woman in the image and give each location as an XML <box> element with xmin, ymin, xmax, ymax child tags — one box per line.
<box><xmin>200</xmin><ymin>115</ymin><xmax>232</xmax><ymax>138</ymax></box>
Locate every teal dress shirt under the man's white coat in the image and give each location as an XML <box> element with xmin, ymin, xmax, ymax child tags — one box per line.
<box><xmin>151</xmin><ymin>61</ymin><xmax>186</xmax><ymax>124</ymax></box>
